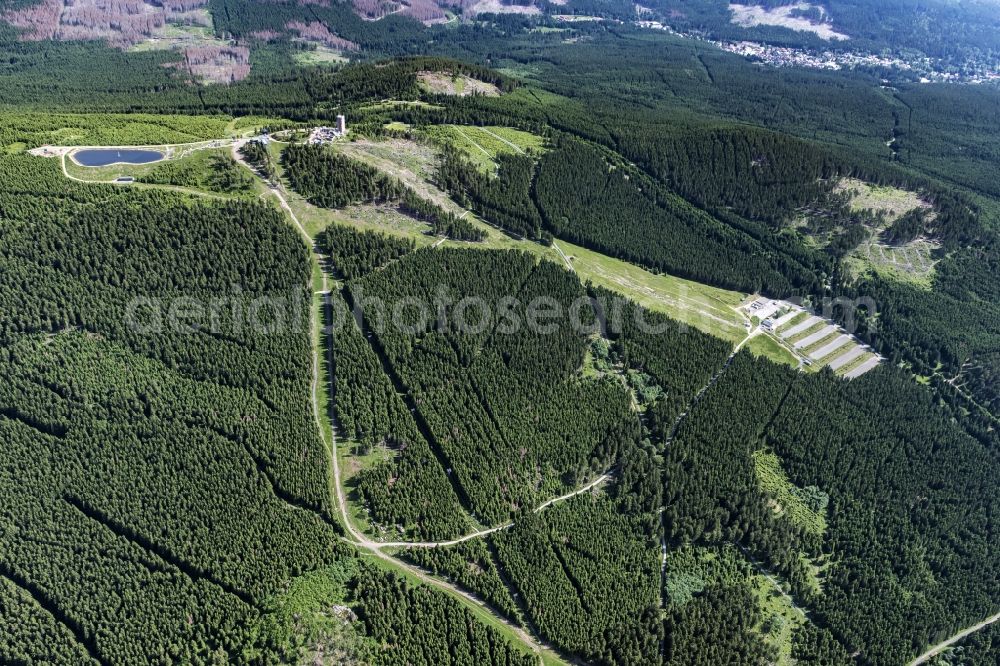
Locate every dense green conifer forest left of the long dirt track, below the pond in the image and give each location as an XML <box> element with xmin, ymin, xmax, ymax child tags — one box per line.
<box><xmin>0</xmin><ymin>157</ymin><xmax>344</xmax><ymax>664</ymax></box>
